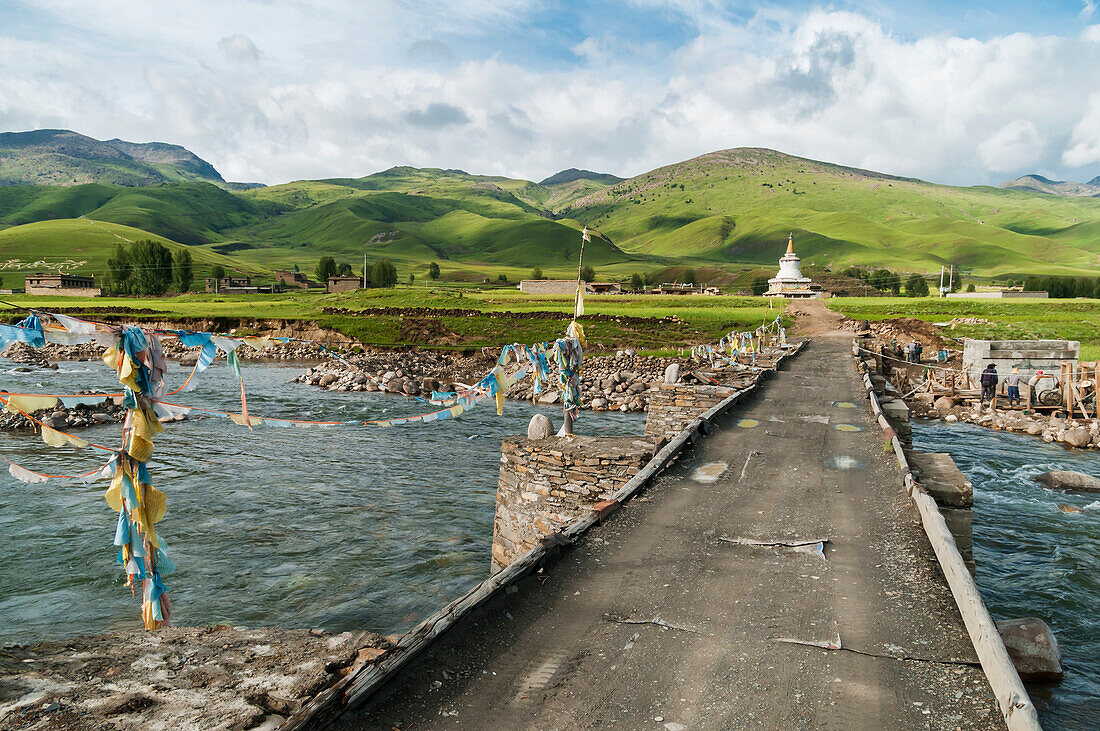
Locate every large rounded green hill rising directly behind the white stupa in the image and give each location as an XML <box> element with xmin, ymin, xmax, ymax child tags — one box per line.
<box><xmin>563</xmin><ymin>148</ymin><xmax>1100</xmax><ymax>275</ymax></box>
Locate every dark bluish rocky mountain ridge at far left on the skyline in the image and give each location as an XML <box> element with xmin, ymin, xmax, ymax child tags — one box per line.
<box><xmin>0</xmin><ymin>130</ymin><xmax>226</xmax><ymax>187</ymax></box>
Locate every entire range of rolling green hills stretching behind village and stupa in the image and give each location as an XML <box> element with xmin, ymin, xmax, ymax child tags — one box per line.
<box><xmin>0</xmin><ymin>148</ymin><xmax>1100</xmax><ymax>284</ymax></box>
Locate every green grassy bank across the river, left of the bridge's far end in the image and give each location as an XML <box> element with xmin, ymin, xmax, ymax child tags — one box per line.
<box><xmin>0</xmin><ymin>286</ymin><xmax>783</xmax><ymax>353</ymax></box>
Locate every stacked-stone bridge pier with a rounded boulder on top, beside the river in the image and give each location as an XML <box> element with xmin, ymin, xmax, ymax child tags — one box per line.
<box><xmin>492</xmin><ymin>436</ymin><xmax>653</xmax><ymax>574</ymax></box>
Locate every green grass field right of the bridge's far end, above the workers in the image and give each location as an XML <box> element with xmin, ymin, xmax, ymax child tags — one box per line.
<box><xmin>826</xmin><ymin>297</ymin><xmax>1100</xmax><ymax>361</ymax></box>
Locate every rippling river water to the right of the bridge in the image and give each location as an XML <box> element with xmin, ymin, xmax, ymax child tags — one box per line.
<box><xmin>913</xmin><ymin>421</ymin><xmax>1100</xmax><ymax>731</ymax></box>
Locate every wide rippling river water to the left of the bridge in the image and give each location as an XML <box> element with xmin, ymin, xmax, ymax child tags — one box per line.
<box><xmin>0</xmin><ymin>361</ymin><xmax>645</xmax><ymax>644</ymax></box>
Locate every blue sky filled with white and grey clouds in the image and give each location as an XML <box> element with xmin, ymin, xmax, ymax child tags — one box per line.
<box><xmin>0</xmin><ymin>0</ymin><xmax>1100</xmax><ymax>185</ymax></box>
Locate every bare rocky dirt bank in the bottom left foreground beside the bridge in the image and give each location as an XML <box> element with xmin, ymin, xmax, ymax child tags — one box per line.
<box><xmin>0</xmin><ymin>625</ymin><xmax>393</xmax><ymax>731</ymax></box>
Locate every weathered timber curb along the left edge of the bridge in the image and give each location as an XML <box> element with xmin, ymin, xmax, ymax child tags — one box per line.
<box><xmin>279</xmin><ymin>340</ymin><xmax>807</xmax><ymax>731</ymax></box>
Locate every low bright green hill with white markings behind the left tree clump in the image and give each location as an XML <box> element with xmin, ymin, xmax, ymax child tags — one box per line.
<box><xmin>0</xmin><ymin>219</ymin><xmax>241</xmax><ymax>288</ymax></box>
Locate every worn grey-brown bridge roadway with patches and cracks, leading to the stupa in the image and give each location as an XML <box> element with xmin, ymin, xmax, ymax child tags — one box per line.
<box><xmin>336</xmin><ymin>336</ymin><xmax>1004</xmax><ymax>731</ymax></box>
